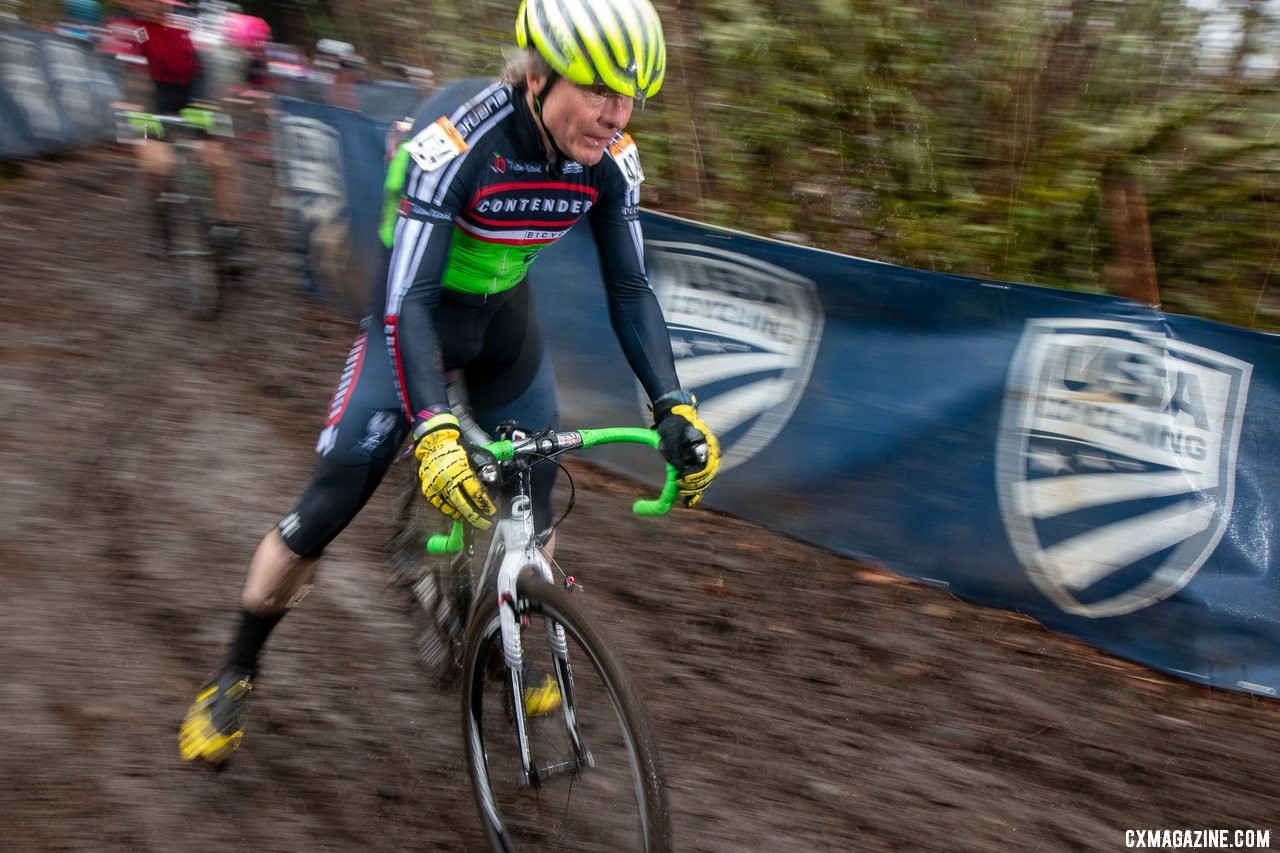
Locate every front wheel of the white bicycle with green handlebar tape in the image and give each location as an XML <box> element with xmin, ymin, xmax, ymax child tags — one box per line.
<box><xmin>462</xmin><ymin>575</ymin><xmax>672</xmax><ymax>852</ymax></box>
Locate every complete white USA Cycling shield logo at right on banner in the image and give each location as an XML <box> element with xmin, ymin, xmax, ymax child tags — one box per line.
<box><xmin>996</xmin><ymin>319</ymin><xmax>1252</xmax><ymax>617</ymax></box>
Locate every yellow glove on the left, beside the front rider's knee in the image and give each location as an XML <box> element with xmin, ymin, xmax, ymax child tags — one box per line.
<box><xmin>413</xmin><ymin>414</ymin><xmax>495</xmax><ymax>530</ymax></box>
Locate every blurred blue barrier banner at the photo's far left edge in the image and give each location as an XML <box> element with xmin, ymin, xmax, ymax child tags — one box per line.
<box><xmin>0</xmin><ymin>29</ymin><xmax>120</xmax><ymax>156</ymax></box>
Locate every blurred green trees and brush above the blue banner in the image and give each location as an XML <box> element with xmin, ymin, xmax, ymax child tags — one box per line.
<box><xmin>33</xmin><ymin>0</ymin><xmax>1280</xmax><ymax>330</ymax></box>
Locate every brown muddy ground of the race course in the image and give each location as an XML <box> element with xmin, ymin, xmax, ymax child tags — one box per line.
<box><xmin>0</xmin><ymin>147</ymin><xmax>1280</xmax><ymax>853</ymax></box>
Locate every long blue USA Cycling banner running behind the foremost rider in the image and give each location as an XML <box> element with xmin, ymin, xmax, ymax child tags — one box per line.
<box><xmin>277</xmin><ymin>87</ymin><xmax>1280</xmax><ymax>697</ymax></box>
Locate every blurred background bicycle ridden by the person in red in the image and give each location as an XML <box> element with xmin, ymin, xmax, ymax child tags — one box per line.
<box><xmin>116</xmin><ymin>108</ymin><xmax>236</xmax><ymax>319</ymax></box>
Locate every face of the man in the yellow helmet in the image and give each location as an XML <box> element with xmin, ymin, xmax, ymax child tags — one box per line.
<box><xmin>529</xmin><ymin>76</ymin><xmax>635</xmax><ymax>165</ymax></box>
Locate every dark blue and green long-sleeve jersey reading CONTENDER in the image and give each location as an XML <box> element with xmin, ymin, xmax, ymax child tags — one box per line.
<box><xmin>372</xmin><ymin>79</ymin><xmax>680</xmax><ymax>421</ymax></box>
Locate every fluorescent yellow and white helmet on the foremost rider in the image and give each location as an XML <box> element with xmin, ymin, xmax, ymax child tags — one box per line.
<box><xmin>516</xmin><ymin>0</ymin><xmax>667</xmax><ymax>97</ymax></box>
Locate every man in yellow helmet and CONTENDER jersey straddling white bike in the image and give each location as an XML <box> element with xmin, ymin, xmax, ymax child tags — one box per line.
<box><xmin>179</xmin><ymin>0</ymin><xmax>719</xmax><ymax>763</ymax></box>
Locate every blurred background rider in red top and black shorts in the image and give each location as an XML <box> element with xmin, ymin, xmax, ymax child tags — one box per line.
<box><xmin>122</xmin><ymin>0</ymin><xmax>243</xmax><ymax>261</ymax></box>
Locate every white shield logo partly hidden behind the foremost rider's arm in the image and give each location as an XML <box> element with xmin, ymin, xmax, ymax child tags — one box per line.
<box><xmin>641</xmin><ymin>241</ymin><xmax>823</xmax><ymax>469</ymax></box>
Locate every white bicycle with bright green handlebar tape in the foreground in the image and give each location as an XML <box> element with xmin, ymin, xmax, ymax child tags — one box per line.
<box><xmin>398</xmin><ymin>424</ymin><xmax>676</xmax><ymax>852</ymax></box>
